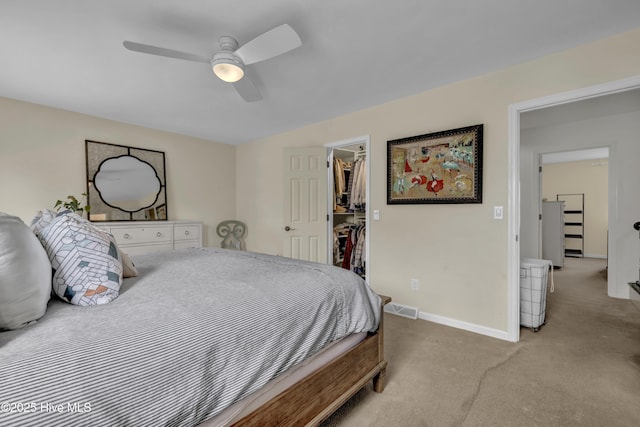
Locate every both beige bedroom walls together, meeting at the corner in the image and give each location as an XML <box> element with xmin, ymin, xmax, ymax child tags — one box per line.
<box><xmin>0</xmin><ymin>30</ymin><xmax>640</xmax><ymax>340</ymax></box>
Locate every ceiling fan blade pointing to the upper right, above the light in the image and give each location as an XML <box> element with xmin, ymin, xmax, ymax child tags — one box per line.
<box><xmin>235</xmin><ymin>24</ymin><xmax>302</xmax><ymax>65</ymax></box>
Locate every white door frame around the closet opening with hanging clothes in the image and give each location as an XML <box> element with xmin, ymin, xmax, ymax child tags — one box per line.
<box><xmin>324</xmin><ymin>135</ymin><xmax>371</xmax><ymax>283</ymax></box>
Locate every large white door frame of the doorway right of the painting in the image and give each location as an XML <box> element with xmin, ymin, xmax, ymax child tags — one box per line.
<box><xmin>507</xmin><ymin>76</ymin><xmax>640</xmax><ymax>342</ymax></box>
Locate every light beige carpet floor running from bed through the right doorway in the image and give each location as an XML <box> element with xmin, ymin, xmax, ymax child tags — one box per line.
<box><xmin>322</xmin><ymin>258</ymin><xmax>640</xmax><ymax>427</ymax></box>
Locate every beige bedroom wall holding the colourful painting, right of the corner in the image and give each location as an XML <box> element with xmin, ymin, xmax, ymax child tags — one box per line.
<box><xmin>236</xmin><ymin>30</ymin><xmax>640</xmax><ymax>331</ymax></box>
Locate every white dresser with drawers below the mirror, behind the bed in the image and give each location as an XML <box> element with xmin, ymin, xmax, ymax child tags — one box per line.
<box><xmin>94</xmin><ymin>221</ymin><xmax>202</xmax><ymax>255</ymax></box>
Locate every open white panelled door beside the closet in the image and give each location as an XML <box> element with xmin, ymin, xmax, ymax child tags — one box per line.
<box><xmin>282</xmin><ymin>147</ymin><xmax>327</xmax><ymax>264</ymax></box>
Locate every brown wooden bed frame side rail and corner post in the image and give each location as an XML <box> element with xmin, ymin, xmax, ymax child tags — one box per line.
<box><xmin>233</xmin><ymin>295</ymin><xmax>391</xmax><ymax>427</ymax></box>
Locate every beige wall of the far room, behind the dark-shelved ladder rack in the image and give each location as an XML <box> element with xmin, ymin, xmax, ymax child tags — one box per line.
<box><xmin>542</xmin><ymin>159</ymin><xmax>609</xmax><ymax>258</ymax></box>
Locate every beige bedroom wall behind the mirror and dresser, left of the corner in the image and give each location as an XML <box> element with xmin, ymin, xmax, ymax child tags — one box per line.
<box><xmin>0</xmin><ymin>98</ymin><xmax>236</xmax><ymax>246</ymax></box>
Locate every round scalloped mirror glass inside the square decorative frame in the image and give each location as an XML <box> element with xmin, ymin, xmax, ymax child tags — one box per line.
<box><xmin>93</xmin><ymin>155</ymin><xmax>162</xmax><ymax>212</ymax></box>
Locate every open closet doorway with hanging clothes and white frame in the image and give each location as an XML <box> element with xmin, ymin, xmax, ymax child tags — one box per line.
<box><xmin>325</xmin><ymin>135</ymin><xmax>371</xmax><ymax>282</ymax></box>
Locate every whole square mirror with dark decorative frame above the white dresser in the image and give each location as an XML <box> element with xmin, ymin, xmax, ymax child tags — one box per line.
<box><xmin>85</xmin><ymin>140</ymin><xmax>167</xmax><ymax>221</ymax></box>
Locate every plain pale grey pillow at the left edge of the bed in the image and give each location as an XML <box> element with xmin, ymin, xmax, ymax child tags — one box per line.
<box><xmin>0</xmin><ymin>212</ymin><xmax>51</xmax><ymax>330</ymax></box>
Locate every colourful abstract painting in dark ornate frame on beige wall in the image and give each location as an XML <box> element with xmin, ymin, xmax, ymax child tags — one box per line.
<box><xmin>387</xmin><ymin>124</ymin><xmax>483</xmax><ymax>205</ymax></box>
